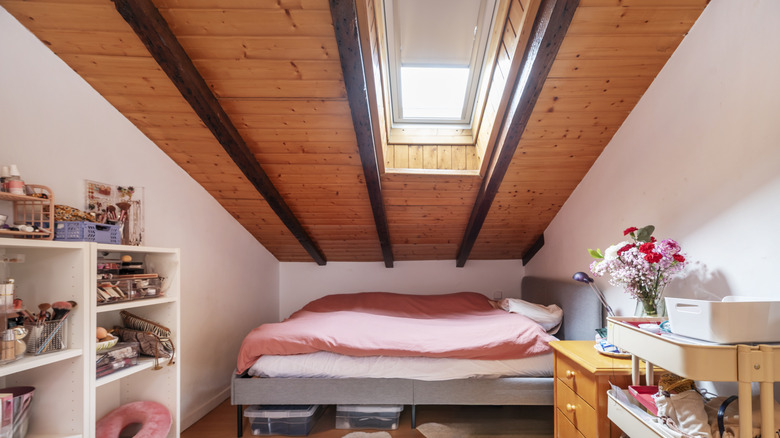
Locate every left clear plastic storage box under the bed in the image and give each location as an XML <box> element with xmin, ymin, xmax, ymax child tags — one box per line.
<box><xmin>244</xmin><ymin>405</ymin><xmax>320</xmax><ymax>436</ymax></box>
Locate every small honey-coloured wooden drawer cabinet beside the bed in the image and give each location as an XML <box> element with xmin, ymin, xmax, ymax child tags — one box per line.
<box><xmin>550</xmin><ymin>341</ymin><xmax>656</xmax><ymax>438</ymax></box>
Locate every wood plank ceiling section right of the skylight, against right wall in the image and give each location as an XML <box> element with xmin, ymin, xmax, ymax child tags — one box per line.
<box><xmin>472</xmin><ymin>0</ymin><xmax>708</xmax><ymax>259</ymax></box>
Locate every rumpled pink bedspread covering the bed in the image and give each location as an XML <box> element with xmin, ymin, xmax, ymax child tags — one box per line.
<box><xmin>238</xmin><ymin>292</ymin><xmax>555</xmax><ymax>373</ymax></box>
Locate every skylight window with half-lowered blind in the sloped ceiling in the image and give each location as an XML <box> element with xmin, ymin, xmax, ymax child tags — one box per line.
<box><xmin>384</xmin><ymin>0</ymin><xmax>497</xmax><ymax>128</ymax></box>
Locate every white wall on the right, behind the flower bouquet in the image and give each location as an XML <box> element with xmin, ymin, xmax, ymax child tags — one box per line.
<box><xmin>526</xmin><ymin>0</ymin><xmax>780</xmax><ymax>313</ymax></box>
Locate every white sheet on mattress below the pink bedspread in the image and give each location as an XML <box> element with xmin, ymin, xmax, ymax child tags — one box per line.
<box><xmin>248</xmin><ymin>351</ymin><xmax>553</xmax><ymax>380</ymax></box>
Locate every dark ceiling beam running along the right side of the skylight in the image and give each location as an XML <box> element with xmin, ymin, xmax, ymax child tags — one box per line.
<box><xmin>456</xmin><ymin>0</ymin><xmax>579</xmax><ymax>267</ymax></box>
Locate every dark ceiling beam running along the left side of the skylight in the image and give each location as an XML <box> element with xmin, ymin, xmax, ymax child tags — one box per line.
<box><xmin>330</xmin><ymin>0</ymin><xmax>393</xmax><ymax>268</ymax></box>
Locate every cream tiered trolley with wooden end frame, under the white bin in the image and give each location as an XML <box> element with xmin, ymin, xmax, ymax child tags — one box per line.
<box><xmin>607</xmin><ymin>317</ymin><xmax>780</xmax><ymax>438</ymax></box>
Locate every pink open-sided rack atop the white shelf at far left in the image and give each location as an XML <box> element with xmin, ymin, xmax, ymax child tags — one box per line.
<box><xmin>0</xmin><ymin>184</ymin><xmax>54</xmax><ymax>240</ymax></box>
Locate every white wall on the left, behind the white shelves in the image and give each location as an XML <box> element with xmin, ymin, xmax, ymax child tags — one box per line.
<box><xmin>0</xmin><ymin>8</ymin><xmax>279</xmax><ymax>427</ymax></box>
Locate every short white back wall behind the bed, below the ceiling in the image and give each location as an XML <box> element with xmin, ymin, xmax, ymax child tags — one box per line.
<box><xmin>279</xmin><ymin>260</ymin><xmax>524</xmax><ymax>318</ymax></box>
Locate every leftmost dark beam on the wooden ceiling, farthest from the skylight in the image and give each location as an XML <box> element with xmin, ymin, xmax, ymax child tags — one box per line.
<box><xmin>113</xmin><ymin>0</ymin><xmax>326</xmax><ymax>265</ymax></box>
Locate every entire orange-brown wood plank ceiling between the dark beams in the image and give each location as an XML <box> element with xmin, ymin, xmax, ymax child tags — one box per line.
<box><xmin>0</xmin><ymin>0</ymin><xmax>707</xmax><ymax>262</ymax></box>
